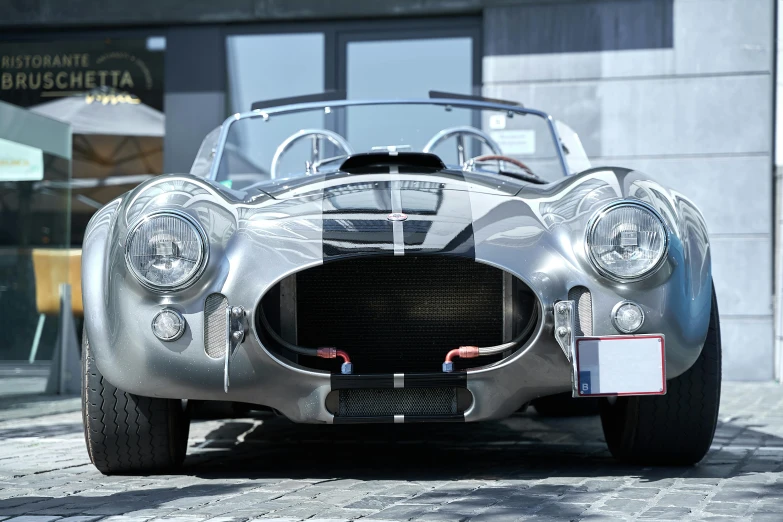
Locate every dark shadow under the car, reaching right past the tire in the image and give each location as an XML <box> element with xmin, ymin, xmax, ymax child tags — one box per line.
<box><xmin>183</xmin><ymin>413</ymin><xmax>783</xmax><ymax>481</ymax></box>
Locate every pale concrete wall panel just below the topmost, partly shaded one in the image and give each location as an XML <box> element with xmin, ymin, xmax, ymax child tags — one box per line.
<box><xmin>484</xmin><ymin>75</ymin><xmax>772</xmax><ymax>157</ymax></box>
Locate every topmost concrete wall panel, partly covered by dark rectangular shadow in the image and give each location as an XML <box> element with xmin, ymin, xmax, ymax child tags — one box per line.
<box><xmin>484</xmin><ymin>0</ymin><xmax>774</xmax><ymax>82</ymax></box>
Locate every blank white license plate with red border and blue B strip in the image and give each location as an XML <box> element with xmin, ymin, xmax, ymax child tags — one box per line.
<box><xmin>575</xmin><ymin>335</ymin><xmax>666</xmax><ymax>397</ymax></box>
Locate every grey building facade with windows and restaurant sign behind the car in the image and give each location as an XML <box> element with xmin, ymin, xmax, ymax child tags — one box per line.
<box><xmin>0</xmin><ymin>0</ymin><xmax>783</xmax><ymax>380</ymax></box>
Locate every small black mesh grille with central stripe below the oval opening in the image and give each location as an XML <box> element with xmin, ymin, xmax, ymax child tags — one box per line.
<box><xmin>336</xmin><ymin>388</ymin><xmax>462</xmax><ymax>417</ymax></box>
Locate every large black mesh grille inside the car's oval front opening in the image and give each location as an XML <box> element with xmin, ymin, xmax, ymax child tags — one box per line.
<box><xmin>297</xmin><ymin>256</ymin><xmax>503</xmax><ymax>373</ymax></box>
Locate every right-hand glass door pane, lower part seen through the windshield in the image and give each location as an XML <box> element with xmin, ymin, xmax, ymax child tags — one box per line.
<box><xmin>337</xmin><ymin>27</ymin><xmax>480</xmax><ymax>161</ymax></box>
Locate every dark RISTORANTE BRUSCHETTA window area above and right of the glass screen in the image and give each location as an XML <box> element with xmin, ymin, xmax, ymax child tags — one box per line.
<box><xmin>0</xmin><ymin>37</ymin><xmax>165</xmax><ymax>247</ymax></box>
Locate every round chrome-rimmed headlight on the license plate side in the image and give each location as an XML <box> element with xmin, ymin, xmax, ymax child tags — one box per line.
<box><xmin>587</xmin><ymin>201</ymin><xmax>668</xmax><ymax>281</ymax></box>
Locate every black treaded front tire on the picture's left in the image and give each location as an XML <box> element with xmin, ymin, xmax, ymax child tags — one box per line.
<box><xmin>82</xmin><ymin>331</ymin><xmax>190</xmax><ymax>475</ymax></box>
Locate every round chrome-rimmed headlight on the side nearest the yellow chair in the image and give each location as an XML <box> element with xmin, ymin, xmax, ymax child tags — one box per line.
<box><xmin>125</xmin><ymin>211</ymin><xmax>207</xmax><ymax>290</ymax></box>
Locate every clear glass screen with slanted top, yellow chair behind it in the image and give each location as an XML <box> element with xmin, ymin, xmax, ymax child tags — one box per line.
<box><xmin>0</xmin><ymin>102</ymin><xmax>71</xmax><ymax>361</ymax></box>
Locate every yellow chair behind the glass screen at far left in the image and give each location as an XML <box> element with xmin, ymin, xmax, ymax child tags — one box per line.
<box><xmin>30</xmin><ymin>248</ymin><xmax>84</xmax><ymax>363</ymax></box>
